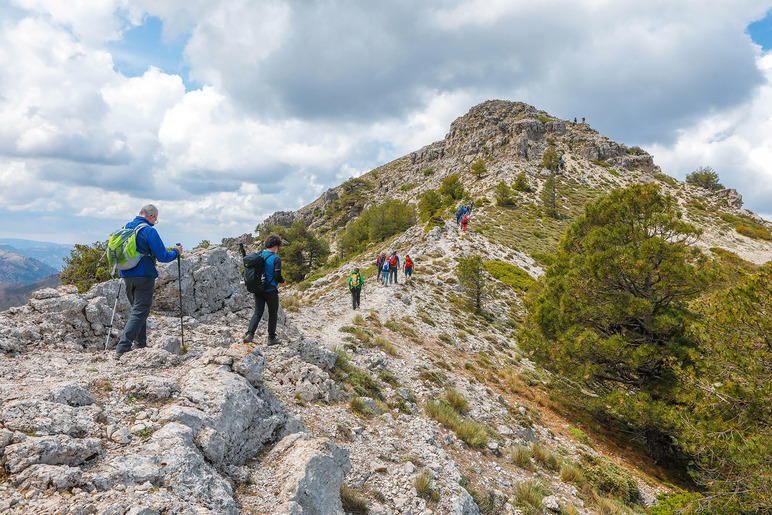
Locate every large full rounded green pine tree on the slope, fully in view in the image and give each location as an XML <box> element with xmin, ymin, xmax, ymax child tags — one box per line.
<box><xmin>521</xmin><ymin>184</ymin><xmax>710</xmax><ymax>458</ymax></box>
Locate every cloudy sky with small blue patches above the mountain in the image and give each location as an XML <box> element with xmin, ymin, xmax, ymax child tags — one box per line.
<box><xmin>0</xmin><ymin>0</ymin><xmax>772</xmax><ymax>247</ymax></box>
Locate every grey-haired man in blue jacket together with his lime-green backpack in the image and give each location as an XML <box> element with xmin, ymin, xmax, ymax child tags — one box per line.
<box><xmin>107</xmin><ymin>204</ymin><xmax>182</xmax><ymax>360</ymax></box>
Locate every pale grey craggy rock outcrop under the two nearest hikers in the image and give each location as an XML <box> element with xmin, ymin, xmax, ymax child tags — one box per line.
<box><xmin>0</xmin><ymin>248</ymin><xmax>349</xmax><ymax>514</ymax></box>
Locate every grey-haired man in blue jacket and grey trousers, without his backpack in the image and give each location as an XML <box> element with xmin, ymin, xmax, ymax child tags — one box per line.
<box><xmin>115</xmin><ymin>204</ymin><xmax>182</xmax><ymax>360</ymax></box>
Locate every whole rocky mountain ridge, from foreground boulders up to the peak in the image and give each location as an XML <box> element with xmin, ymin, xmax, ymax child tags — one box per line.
<box><xmin>0</xmin><ymin>101</ymin><xmax>772</xmax><ymax>515</ymax></box>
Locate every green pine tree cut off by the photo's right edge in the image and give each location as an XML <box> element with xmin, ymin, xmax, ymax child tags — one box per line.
<box><xmin>681</xmin><ymin>264</ymin><xmax>772</xmax><ymax>513</ymax></box>
